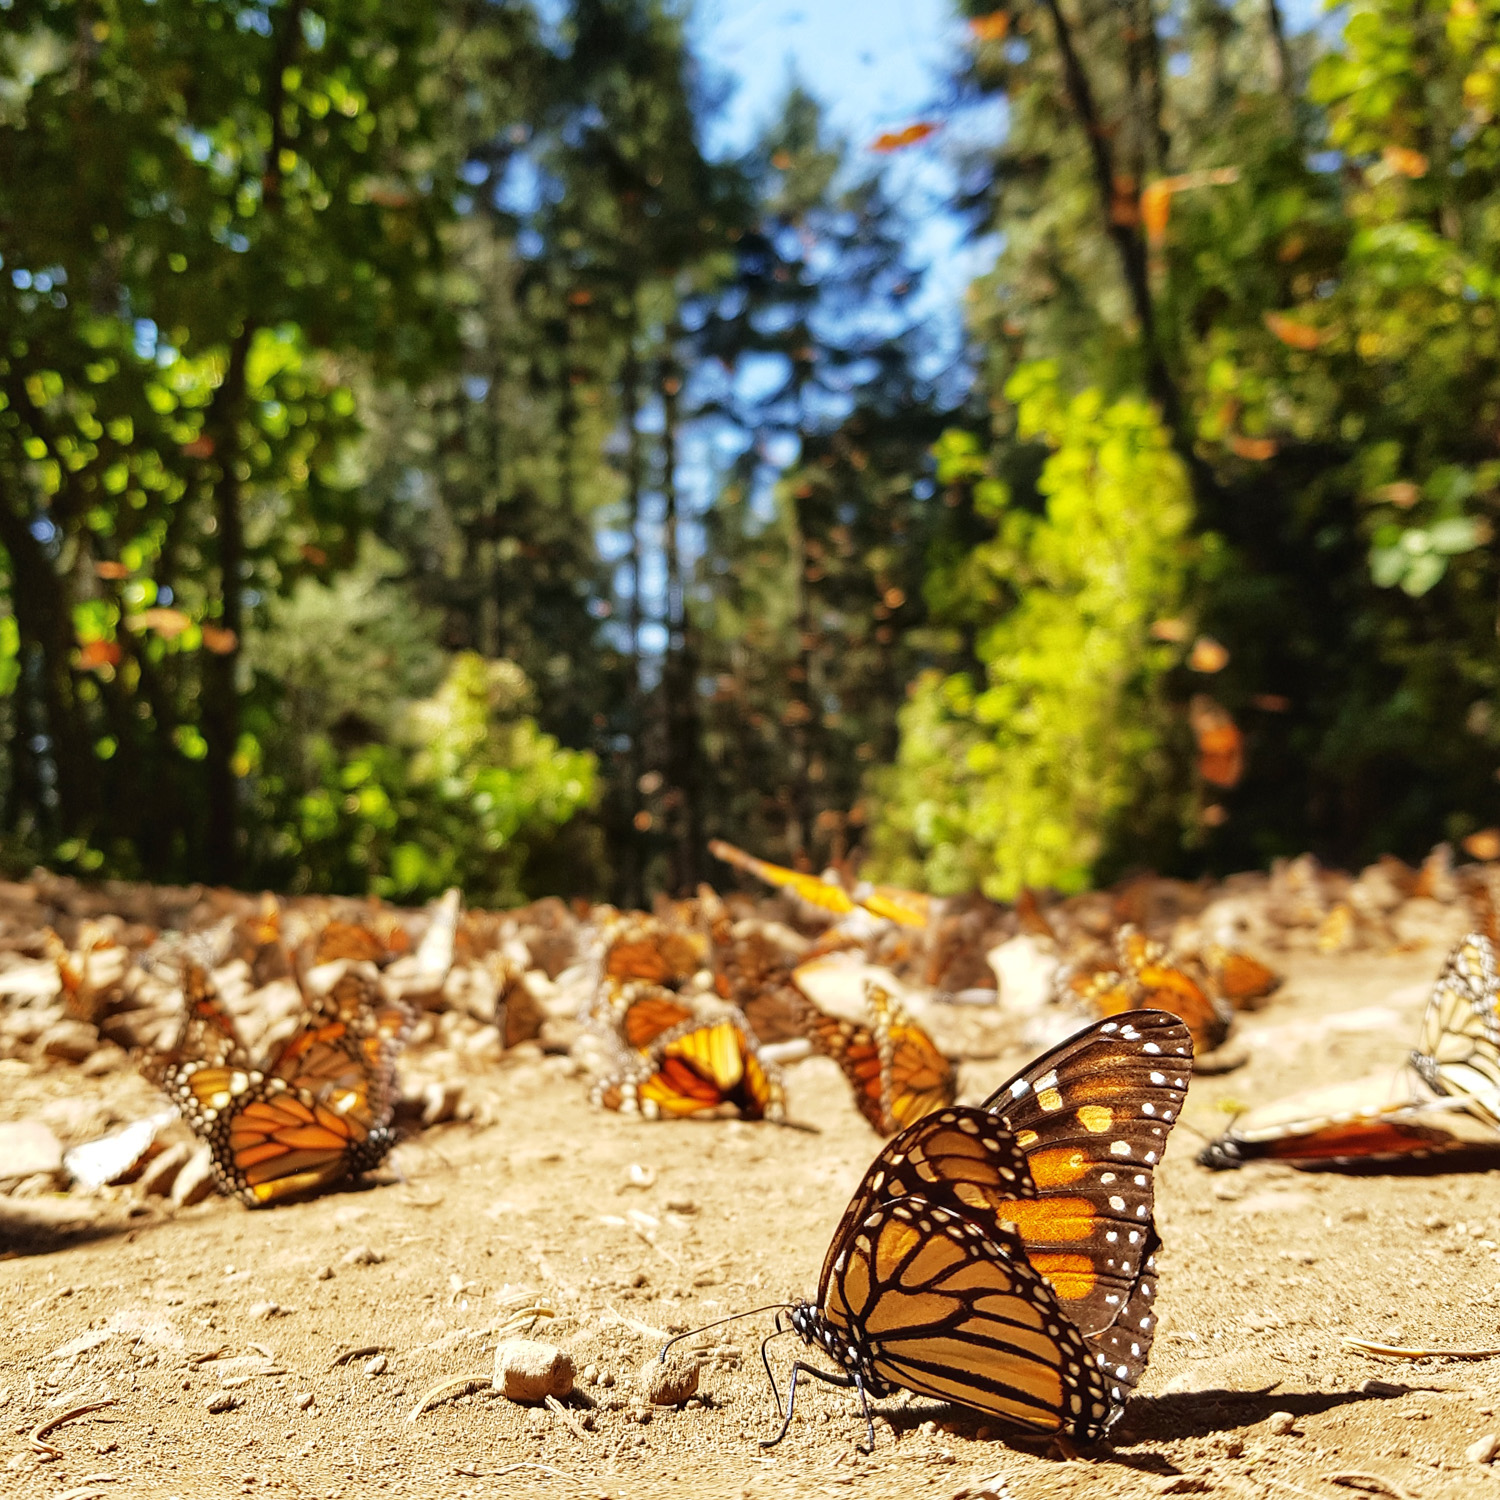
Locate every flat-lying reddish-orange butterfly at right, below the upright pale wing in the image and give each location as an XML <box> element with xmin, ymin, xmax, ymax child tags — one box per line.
<box><xmin>1199</xmin><ymin>1065</ymin><xmax>1500</xmax><ymax>1172</ymax></box>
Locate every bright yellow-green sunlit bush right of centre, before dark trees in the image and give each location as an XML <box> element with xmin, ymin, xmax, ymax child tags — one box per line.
<box><xmin>873</xmin><ymin>363</ymin><xmax>1193</xmax><ymax>900</ymax></box>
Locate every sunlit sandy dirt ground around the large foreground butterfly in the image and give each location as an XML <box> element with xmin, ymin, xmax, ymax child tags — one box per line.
<box><xmin>0</xmin><ymin>945</ymin><xmax>1500</xmax><ymax>1500</ymax></box>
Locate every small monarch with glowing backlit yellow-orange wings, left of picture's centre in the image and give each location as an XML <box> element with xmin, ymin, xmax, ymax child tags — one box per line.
<box><xmin>593</xmin><ymin>1011</ymin><xmax>786</xmax><ymax>1121</ymax></box>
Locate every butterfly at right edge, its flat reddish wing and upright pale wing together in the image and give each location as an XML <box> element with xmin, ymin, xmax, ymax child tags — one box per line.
<box><xmin>1199</xmin><ymin>933</ymin><xmax>1500</xmax><ymax>1170</ymax></box>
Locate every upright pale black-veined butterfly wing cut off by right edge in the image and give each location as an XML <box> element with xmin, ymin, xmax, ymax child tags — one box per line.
<box><xmin>1412</xmin><ymin>932</ymin><xmax>1500</xmax><ymax>1127</ymax></box>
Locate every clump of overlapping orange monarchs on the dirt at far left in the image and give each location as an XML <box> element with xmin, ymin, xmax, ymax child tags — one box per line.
<box><xmin>143</xmin><ymin>963</ymin><xmax>410</xmax><ymax>1208</ymax></box>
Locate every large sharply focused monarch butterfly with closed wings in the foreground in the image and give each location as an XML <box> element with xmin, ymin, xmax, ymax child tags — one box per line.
<box><xmin>663</xmin><ymin>1011</ymin><xmax>1193</xmax><ymax>1452</ymax></box>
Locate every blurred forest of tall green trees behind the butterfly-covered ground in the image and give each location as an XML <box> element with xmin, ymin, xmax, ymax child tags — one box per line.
<box><xmin>0</xmin><ymin>0</ymin><xmax>1500</xmax><ymax>902</ymax></box>
